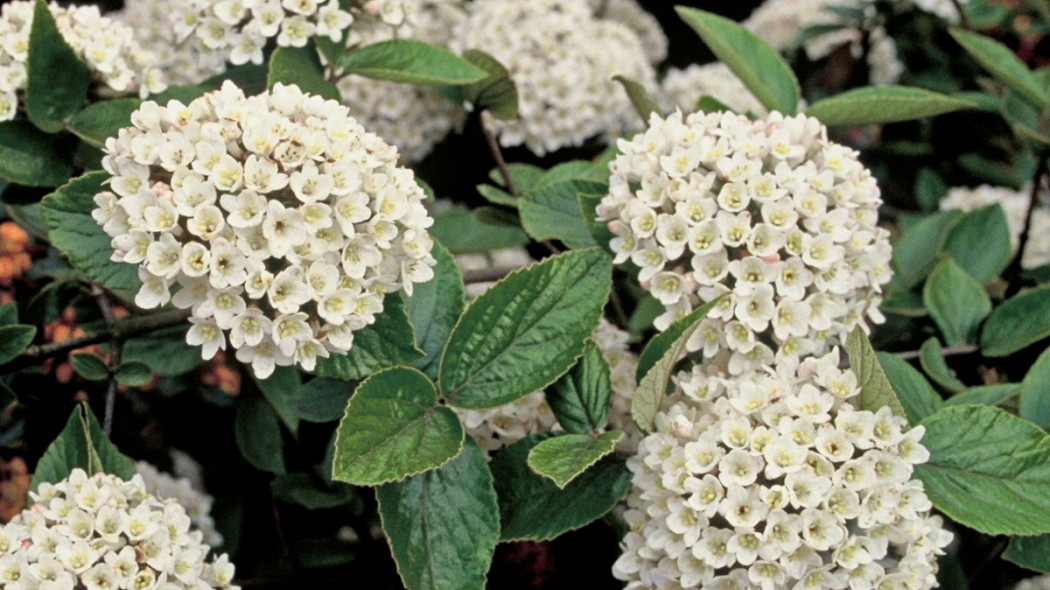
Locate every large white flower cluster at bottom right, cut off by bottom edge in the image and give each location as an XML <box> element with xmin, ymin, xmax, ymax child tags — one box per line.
<box><xmin>613</xmin><ymin>353</ymin><xmax>951</xmax><ymax>590</ymax></box>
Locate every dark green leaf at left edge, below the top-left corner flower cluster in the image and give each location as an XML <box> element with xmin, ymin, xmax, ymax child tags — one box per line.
<box><xmin>0</xmin><ymin>120</ymin><xmax>72</xmax><ymax>187</ymax></box>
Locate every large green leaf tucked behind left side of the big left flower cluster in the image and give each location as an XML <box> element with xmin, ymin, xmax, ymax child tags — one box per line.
<box><xmin>40</xmin><ymin>171</ymin><xmax>142</xmax><ymax>300</ymax></box>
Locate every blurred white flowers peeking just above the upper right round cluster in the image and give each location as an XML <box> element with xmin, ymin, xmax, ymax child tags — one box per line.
<box><xmin>660</xmin><ymin>62</ymin><xmax>767</xmax><ymax>114</ymax></box>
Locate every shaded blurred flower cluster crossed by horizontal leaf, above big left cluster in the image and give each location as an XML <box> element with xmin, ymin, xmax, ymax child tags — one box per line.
<box><xmin>338</xmin><ymin>0</ymin><xmax>466</xmax><ymax>164</ymax></box>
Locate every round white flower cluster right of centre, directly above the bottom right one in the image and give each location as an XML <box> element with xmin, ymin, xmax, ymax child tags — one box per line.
<box><xmin>597</xmin><ymin>112</ymin><xmax>891</xmax><ymax>375</ymax></box>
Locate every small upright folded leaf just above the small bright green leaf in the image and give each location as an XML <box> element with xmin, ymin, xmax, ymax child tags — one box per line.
<box><xmin>546</xmin><ymin>340</ymin><xmax>612</xmax><ymax>435</ymax></box>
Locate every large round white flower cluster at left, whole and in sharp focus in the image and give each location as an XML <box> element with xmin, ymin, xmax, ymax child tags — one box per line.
<box><xmin>92</xmin><ymin>82</ymin><xmax>435</xmax><ymax>377</ymax></box>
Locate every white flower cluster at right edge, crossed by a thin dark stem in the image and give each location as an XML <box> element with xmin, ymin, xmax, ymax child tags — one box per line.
<box><xmin>940</xmin><ymin>185</ymin><xmax>1050</xmax><ymax>269</ymax></box>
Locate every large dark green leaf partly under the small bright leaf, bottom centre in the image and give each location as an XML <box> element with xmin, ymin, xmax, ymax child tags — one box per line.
<box><xmin>489</xmin><ymin>434</ymin><xmax>631</xmax><ymax>541</ymax></box>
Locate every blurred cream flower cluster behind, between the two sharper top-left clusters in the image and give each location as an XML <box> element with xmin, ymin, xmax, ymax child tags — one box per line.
<box><xmin>113</xmin><ymin>0</ymin><xmax>226</xmax><ymax>85</ymax></box>
